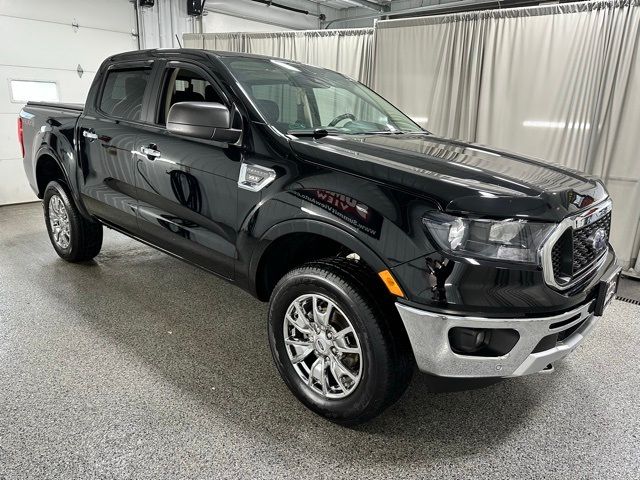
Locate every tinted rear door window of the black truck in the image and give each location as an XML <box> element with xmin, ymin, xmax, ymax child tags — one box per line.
<box><xmin>100</xmin><ymin>68</ymin><xmax>151</xmax><ymax>120</ymax></box>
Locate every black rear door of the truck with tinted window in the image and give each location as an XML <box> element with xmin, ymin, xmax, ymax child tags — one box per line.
<box><xmin>78</xmin><ymin>61</ymin><xmax>153</xmax><ymax>234</ymax></box>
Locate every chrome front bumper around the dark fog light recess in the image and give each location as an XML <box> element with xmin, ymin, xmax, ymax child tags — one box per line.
<box><xmin>396</xmin><ymin>302</ymin><xmax>600</xmax><ymax>378</ymax></box>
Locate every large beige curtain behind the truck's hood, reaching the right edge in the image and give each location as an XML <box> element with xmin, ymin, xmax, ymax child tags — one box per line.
<box><xmin>372</xmin><ymin>0</ymin><xmax>640</xmax><ymax>266</ymax></box>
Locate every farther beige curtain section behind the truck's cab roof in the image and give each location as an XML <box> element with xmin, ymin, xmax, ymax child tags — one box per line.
<box><xmin>184</xmin><ymin>28</ymin><xmax>373</xmax><ymax>84</ymax></box>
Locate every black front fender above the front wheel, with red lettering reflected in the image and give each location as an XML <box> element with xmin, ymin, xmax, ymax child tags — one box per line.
<box><xmin>236</xmin><ymin>172</ymin><xmax>440</xmax><ymax>298</ymax></box>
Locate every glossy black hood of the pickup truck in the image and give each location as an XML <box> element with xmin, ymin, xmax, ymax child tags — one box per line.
<box><xmin>290</xmin><ymin>133</ymin><xmax>607</xmax><ymax>221</ymax></box>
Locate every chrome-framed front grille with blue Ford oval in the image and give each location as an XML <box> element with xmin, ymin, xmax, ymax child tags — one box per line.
<box><xmin>542</xmin><ymin>200</ymin><xmax>611</xmax><ymax>289</ymax></box>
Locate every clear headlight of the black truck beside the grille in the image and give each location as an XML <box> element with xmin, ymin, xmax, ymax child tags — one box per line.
<box><xmin>423</xmin><ymin>212</ymin><xmax>555</xmax><ymax>263</ymax></box>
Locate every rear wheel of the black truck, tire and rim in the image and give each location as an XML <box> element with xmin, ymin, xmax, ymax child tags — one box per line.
<box><xmin>43</xmin><ymin>181</ymin><xmax>102</xmax><ymax>263</ymax></box>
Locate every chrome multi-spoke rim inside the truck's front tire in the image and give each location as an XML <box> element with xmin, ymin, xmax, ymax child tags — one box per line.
<box><xmin>283</xmin><ymin>294</ymin><xmax>363</xmax><ymax>398</ymax></box>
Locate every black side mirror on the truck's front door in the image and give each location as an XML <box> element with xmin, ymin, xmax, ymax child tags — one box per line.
<box><xmin>167</xmin><ymin>102</ymin><xmax>242</xmax><ymax>143</ymax></box>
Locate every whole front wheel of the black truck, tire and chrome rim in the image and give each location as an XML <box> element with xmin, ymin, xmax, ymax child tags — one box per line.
<box><xmin>269</xmin><ymin>258</ymin><xmax>414</xmax><ymax>425</ymax></box>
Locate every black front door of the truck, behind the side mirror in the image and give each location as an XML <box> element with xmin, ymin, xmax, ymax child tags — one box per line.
<box><xmin>135</xmin><ymin>61</ymin><xmax>241</xmax><ymax>279</ymax></box>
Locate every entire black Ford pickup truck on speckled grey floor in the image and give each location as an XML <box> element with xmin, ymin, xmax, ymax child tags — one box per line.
<box><xmin>18</xmin><ymin>49</ymin><xmax>619</xmax><ymax>424</ymax></box>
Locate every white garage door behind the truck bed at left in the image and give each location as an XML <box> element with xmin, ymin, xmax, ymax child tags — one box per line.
<box><xmin>0</xmin><ymin>0</ymin><xmax>137</xmax><ymax>205</ymax></box>
